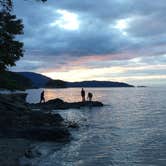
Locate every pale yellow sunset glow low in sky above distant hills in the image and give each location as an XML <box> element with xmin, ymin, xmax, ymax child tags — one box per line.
<box><xmin>42</xmin><ymin>62</ymin><xmax>166</xmax><ymax>84</ymax></box>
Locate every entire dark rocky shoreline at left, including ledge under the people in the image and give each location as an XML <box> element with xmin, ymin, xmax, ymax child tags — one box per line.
<box><xmin>0</xmin><ymin>93</ymin><xmax>103</xmax><ymax>166</ymax></box>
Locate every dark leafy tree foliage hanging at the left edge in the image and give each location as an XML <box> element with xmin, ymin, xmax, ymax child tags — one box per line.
<box><xmin>0</xmin><ymin>10</ymin><xmax>23</xmax><ymax>71</ymax></box>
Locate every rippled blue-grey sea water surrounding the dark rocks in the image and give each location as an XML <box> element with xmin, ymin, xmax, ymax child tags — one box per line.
<box><xmin>22</xmin><ymin>88</ymin><xmax>166</xmax><ymax>166</ymax></box>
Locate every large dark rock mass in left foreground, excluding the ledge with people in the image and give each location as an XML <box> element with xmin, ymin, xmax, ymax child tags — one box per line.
<box><xmin>0</xmin><ymin>94</ymin><xmax>70</xmax><ymax>141</ymax></box>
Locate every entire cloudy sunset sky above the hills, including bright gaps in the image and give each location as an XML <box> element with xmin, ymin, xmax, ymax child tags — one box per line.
<box><xmin>12</xmin><ymin>0</ymin><xmax>166</xmax><ymax>86</ymax></box>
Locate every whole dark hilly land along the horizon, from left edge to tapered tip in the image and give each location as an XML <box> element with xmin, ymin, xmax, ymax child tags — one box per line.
<box><xmin>0</xmin><ymin>71</ymin><xmax>134</xmax><ymax>90</ymax></box>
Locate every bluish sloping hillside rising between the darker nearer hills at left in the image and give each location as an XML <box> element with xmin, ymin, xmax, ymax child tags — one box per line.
<box><xmin>18</xmin><ymin>72</ymin><xmax>52</xmax><ymax>88</ymax></box>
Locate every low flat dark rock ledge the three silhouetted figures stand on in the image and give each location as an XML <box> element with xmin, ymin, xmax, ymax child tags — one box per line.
<box><xmin>29</xmin><ymin>98</ymin><xmax>103</xmax><ymax>110</ymax></box>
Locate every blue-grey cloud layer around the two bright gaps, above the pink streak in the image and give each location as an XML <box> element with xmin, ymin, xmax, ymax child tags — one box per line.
<box><xmin>15</xmin><ymin>0</ymin><xmax>166</xmax><ymax>55</ymax></box>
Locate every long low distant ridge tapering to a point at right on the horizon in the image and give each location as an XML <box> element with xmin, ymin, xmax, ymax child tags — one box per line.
<box><xmin>66</xmin><ymin>81</ymin><xmax>134</xmax><ymax>87</ymax></box>
